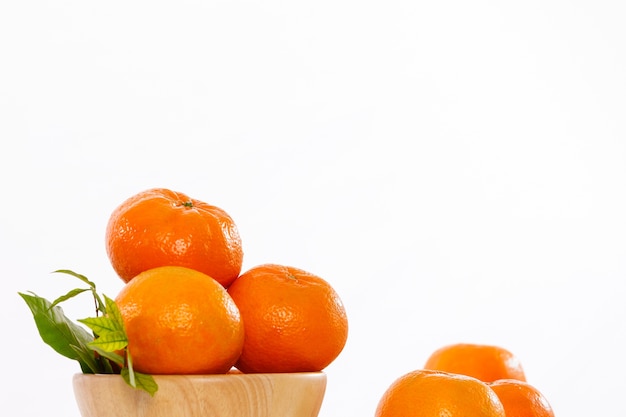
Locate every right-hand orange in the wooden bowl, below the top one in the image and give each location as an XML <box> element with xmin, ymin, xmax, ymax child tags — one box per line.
<box><xmin>228</xmin><ymin>264</ymin><xmax>348</xmax><ymax>373</ymax></box>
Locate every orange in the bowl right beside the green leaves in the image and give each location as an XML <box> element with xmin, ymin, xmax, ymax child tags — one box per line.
<box><xmin>115</xmin><ymin>266</ymin><xmax>244</xmax><ymax>374</ymax></box>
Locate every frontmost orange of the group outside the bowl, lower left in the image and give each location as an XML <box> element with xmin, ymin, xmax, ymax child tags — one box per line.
<box><xmin>375</xmin><ymin>369</ymin><xmax>508</xmax><ymax>417</ymax></box>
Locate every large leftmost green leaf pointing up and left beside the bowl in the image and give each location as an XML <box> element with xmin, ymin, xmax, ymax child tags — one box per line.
<box><xmin>18</xmin><ymin>293</ymin><xmax>93</xmax><ymax>366</ymax></box>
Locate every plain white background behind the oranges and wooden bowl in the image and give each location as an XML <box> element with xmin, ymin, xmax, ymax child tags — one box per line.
<box><xmin>0</xmin><ymin>0</ymin><xmax>626</xmax><ymax>417</ymax></box>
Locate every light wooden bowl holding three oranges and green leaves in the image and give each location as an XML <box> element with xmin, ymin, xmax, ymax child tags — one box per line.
<box><xmin>73</xmin><ymin>372</ymin><xmax>326</xmax><ymax>417</ymax></box>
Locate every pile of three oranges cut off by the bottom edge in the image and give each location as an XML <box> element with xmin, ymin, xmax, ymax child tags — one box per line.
<box><xmin>375</xmin><ymin>343</ymin><xmax>554</xmax><ymax>417</ymax></box>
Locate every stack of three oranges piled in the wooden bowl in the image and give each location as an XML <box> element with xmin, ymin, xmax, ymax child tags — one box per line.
<box><xmin>106</xmin><ymin>188</ymin><xmax>348</xmax><ymax>374</ymax></box>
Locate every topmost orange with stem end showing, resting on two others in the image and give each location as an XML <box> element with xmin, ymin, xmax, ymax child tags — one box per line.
<box><xmin>105</xmin><ymin>188</ymin><xmax>243</xmax><ymax>287</ymax></box>
